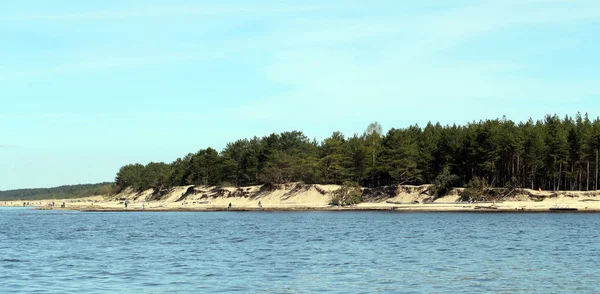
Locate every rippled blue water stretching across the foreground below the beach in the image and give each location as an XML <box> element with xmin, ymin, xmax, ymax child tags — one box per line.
<box><xmin>0</xmin><ymin>208</ymin><xmax>600</xmax><ymax>293</ymax></box>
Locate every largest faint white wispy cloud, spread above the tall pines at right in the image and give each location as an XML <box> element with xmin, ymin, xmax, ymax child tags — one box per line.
<box><xmin>240</xmin><ymin>0</ymin><xmax>600</xmax><ymax>121</ymax></box>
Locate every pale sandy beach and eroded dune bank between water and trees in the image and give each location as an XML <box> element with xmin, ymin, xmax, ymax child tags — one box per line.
<box><xmin>0</xmin><ymin>184</ymin><xmax>600</xmax><ymax>212</ymax></box>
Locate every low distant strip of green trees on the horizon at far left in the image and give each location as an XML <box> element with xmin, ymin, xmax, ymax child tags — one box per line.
<box><xmin>0</xmin><ymin>183</ymin><xmax>115</xmax><ymax>201</ymax></box>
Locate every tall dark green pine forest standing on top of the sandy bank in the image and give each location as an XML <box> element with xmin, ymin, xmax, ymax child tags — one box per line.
<box><xmin>116</xmin><ymin>114</ymin><xmax>600</xmax><ymax>194</ymax></box>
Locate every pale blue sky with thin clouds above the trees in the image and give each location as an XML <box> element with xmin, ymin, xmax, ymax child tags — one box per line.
<box><xmin>0</xmin><ymin>0</ymin><xmax>600</xmax><ymax>190</ymax></box>
